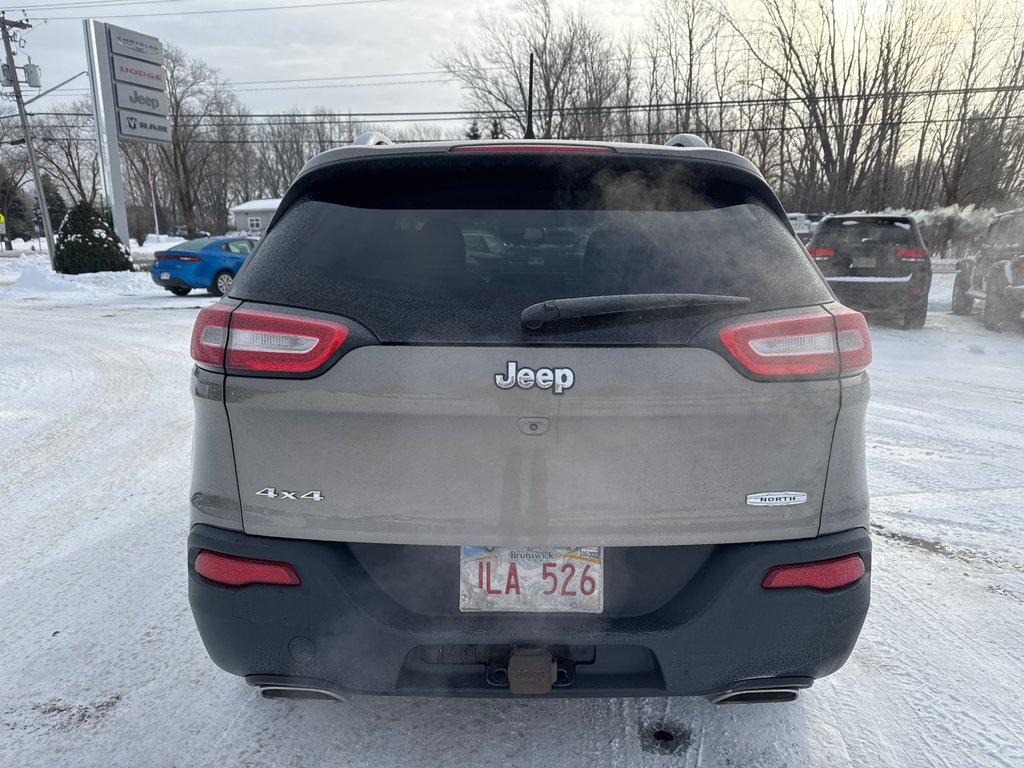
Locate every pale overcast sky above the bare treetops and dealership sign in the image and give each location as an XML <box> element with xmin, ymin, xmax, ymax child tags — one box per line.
<box><xmin>8</xmin><ymin>0</ymin><xmax>651</xmax><ymax>120</ymax></box>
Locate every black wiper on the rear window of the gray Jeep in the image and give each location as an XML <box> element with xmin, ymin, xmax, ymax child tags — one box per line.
<box><xmin>520</xmin><ymin>293</ymin><xmax>750</xmax><ymax>331</ymax></box>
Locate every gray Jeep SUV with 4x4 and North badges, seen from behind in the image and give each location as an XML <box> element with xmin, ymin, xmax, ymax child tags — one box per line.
<box><xmin>188</xmin><ymin>134</ymin><xmax>870</xmax><ymax>702</ymax></box>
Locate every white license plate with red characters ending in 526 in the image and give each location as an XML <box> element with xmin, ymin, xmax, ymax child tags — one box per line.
<box><xmin>459</xmin><ymin>547</ymin><xmax>604</xmax><ymax>613</ymax></box>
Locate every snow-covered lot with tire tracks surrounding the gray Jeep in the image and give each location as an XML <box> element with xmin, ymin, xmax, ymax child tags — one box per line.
<box><xmin>0</xmin><ymin>272</ymin><xmax>1024</xmax><ymax>768</ymax></box>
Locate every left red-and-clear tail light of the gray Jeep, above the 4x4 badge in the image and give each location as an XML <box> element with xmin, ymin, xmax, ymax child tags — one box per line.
<box><xmin>191</xmin><ymin>304</ymin><xmax>348</xmax><ymax>374</ymax></box>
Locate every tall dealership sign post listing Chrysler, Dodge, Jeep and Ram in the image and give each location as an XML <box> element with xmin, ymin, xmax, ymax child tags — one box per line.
<box><xmin>83</xmin><ymin>18</ymin><xmax>171</xmax><ymax>249</ymax></box>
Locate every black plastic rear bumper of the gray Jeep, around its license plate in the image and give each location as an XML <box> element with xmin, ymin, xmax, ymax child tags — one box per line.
<box><xmin>188</xmin><ymin>525</ymin><xmax>870</xmax><ymax>696</ymax></box>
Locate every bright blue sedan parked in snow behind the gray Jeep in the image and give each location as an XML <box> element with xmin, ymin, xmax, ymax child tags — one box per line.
<box><xmin>151</xmin><ymin>237</ymin><xmax>257</xmax><ymax>296</ymax></box>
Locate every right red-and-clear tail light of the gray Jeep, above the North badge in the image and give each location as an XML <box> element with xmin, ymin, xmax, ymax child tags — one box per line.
<box><xmin>719</xmin><ymin>307</ymin><xmax>871</xmax><ymax>378</ymax></box>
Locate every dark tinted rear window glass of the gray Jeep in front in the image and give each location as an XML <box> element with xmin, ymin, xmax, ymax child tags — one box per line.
<box><xmin>231</xmin><ymin>158</ymin><xmax>831</xmax><ymax>344</ymax></box>
